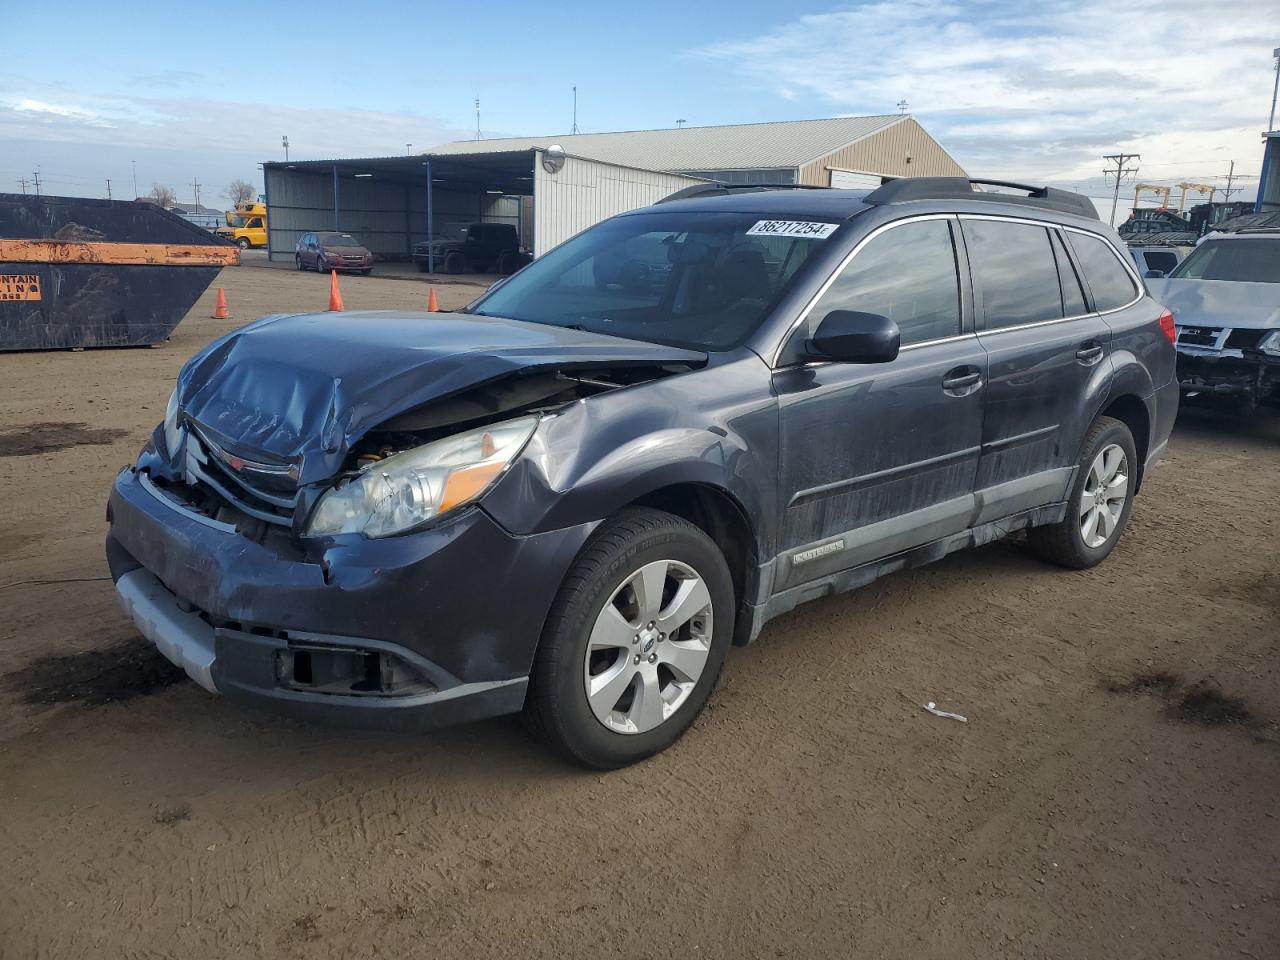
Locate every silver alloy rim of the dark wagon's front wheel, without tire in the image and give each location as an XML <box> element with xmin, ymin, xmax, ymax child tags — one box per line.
<box><xmin>582</xmin><ymin>559</ymin><xmax>713</xmax><ymax>733</ymax></box>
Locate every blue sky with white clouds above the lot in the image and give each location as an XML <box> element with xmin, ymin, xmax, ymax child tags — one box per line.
<box><xmin>0</xmin><ymin>0</ymin><xmax>1280</xmax><ymax>216</ymax></box>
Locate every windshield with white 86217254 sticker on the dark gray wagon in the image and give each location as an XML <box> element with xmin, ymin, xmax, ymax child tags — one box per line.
<box><xmin>460</xmin><ymin>211</ymin><xmax>838</xmax><ymax>349</ymax></box>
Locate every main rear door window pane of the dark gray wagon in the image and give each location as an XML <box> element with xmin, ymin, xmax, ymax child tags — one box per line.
<box><xmin>964</xmin><ymin>218</ymin><xmax>1064</xmax><ymax>330</ymax></box>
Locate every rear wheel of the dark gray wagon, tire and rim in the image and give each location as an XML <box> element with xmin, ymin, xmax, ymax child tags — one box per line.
<box><xmin>1027</xmin><ymin>417</ymin><xmax>1138</xmax><ymax>570</ymax></box>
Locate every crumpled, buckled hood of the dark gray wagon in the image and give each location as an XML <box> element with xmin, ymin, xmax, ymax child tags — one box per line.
<box><xmin>178</xmin><ymin>310</ymin><xmax>707</xmax><ymax>484</ymax></box>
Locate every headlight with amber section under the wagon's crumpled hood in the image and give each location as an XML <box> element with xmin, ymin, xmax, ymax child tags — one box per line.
<box><xmin>307</xmin><ymin>417</ymin><xmax>538</xmax><ymax>538</ymax></box>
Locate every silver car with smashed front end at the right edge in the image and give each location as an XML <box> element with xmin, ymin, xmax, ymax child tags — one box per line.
<box><xmin>1147</xmin><ymin>229</ymin><xmax>1280</xmax><ymax>413</ymax></box>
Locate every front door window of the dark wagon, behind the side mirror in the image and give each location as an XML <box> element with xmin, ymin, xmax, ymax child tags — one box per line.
<box><xmin>801</xmin><ymin>220</ymin><xmax>960</xmax><ymax>346</ymax></box>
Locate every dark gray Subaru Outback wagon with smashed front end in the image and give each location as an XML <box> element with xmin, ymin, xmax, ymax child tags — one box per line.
<box><xmin>106</xmin><ymin>178</ymin><xmax>1179</xmax><ymax>768</ymax></box>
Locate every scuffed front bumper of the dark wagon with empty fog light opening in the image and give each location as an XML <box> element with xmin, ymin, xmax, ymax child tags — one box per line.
<box><xmin>106</xmin><ymin>468</ymin><xmax>589</xmax><ymax>730</ymax></box>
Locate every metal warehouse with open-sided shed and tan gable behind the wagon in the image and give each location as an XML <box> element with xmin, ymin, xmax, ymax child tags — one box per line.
<box><xmin>262</xmin><ymin>115</ymin><xmax>965</xmax><ymax>267</ymax></box>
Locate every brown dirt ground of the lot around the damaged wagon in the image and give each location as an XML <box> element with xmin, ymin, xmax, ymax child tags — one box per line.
<box><xmin>0</xmin><ymin>266</ymin><xmax>1280</xmax><ymax>960</ymax></box>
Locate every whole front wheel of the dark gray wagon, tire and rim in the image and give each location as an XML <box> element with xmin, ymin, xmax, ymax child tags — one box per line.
<box><xmin>525</xmin><ymin>509</ymin><xmax>735</xmax><ymax>769</ymax></box>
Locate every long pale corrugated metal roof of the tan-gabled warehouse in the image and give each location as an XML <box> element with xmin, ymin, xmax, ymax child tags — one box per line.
<box><xmin>428</xmin><ymin>114</ymin><xmax>906</xmax><ymax>172</ymax></box>
